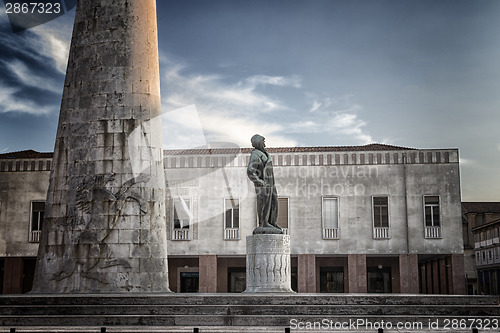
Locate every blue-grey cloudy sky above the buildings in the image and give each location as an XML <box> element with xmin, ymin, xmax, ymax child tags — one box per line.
<box><xmin>0</xmin><ymin>0</ymin><xmax>500</xmax><ymax>201</ymax></box>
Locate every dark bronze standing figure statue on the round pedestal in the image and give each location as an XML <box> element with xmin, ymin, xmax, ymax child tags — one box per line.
<box><xmin>247</xmin><ymin>134</ymin><xmax>283</xmax><ymax>234</ymax></box>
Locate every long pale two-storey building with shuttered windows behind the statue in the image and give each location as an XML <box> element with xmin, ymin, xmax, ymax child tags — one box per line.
<box><xmin>0</xmin><ymin>144</ymin><xmax>465</xmax><ymax>294</ymax></box>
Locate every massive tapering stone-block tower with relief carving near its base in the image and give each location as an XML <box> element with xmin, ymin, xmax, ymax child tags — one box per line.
<box><xmin>33</xmin><ymin>0</ymin><xmax>169</xmax><ymax>293</ymax></box>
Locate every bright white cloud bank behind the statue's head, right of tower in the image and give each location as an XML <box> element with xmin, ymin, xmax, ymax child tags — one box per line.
<box><xmin>160</xmin><ymin>56</ymin><xmax>300</xmax><ymax>148</ymax></box>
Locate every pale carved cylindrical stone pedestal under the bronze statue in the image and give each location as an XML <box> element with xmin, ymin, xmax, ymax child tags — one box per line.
<box><xmin>245</xmin><ymin>234</ymin><xmax>293</xmax><ymax>293</ymax></box>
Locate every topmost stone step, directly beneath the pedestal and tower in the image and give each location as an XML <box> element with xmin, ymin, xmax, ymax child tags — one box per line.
<box><xmin>0</xmin><ymin>293</ymin><xmax>500</xmax><ymax>306</ymax></box>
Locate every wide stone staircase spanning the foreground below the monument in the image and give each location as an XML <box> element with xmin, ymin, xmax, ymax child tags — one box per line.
<box><xmin>0</xmin><ymin>293</ymin><xmax>500</xmax><ymax>333</ymax></box>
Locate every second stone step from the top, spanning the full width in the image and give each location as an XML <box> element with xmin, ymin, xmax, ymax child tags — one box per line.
<box><xmin>0</xmin><ymin>304</ymin><xmax>498</xmax><ymax>316</ymax></box>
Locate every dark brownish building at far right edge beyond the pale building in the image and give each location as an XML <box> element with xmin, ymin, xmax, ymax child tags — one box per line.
<box><xmin>462</xmin><ymin>202</ymin><xmax>500</xmax><ymax>295</ymax></box>
